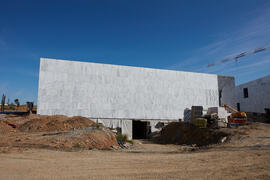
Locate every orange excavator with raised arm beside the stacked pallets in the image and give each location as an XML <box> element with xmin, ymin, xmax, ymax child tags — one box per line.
<box><xmin>223</xmin><ymin>104</ymin><xmax>247</xmax><ymax>126</ymax></box>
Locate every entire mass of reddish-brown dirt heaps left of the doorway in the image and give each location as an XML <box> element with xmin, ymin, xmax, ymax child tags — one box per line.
<box><xmin>0</xmin><ymin>115</ymin><xmax>118</xmax><ymax>150</ymax></box>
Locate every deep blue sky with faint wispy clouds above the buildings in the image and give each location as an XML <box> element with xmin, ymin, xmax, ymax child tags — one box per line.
<box><xmin>0</xmin><ymin>0</ymin><xmax>270</xmax><ymax>103</ymax></box>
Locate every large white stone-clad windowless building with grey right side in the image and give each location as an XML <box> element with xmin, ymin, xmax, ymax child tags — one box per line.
<box><xmin>37</xmin><ymin>58</ymin><xmax>235</xmax><ymax>138</ymax></box>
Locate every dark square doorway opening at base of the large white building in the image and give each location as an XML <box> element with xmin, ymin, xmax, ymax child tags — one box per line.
<box><xmin>132</xmin><ymin>120</ymin><xmax>151</xmax><ymax>139</ymax></box>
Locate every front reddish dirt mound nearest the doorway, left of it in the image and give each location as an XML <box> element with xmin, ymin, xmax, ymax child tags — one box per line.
<box><xmin>31</xmin><ymin>126</ymin><xmax>118</xmax><ymax>150</ymax></box>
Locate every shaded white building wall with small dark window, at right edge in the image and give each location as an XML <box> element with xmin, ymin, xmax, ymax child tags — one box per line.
<box><xmin>235</xmin><ymin>76</ymin><xmax>270</xmax><ymax>113</ymax></box>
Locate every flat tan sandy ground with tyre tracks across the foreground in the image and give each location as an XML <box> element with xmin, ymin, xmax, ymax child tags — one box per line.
<box><xmin>0</xmin><ymin>123</ymin><xmax>270</xmax><ymax>179</ymax></box>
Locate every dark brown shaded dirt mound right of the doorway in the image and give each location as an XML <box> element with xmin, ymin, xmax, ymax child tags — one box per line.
<box><xmin>154</xmin><ymin>122</ymin><xmax>228</xmax><ymax>146</ymax></box>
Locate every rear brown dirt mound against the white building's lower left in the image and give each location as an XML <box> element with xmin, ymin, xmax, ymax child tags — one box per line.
<box><xmin>19</xmin><ymin>115</ymin><xmax>95</xmax><ymax>132</ymax></box>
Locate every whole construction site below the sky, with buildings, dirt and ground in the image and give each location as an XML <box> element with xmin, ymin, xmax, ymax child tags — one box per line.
<box><xmin>0</xmin><ymin>57</ymin><xmax>270</xmax><ymax>179</ymax></box>
